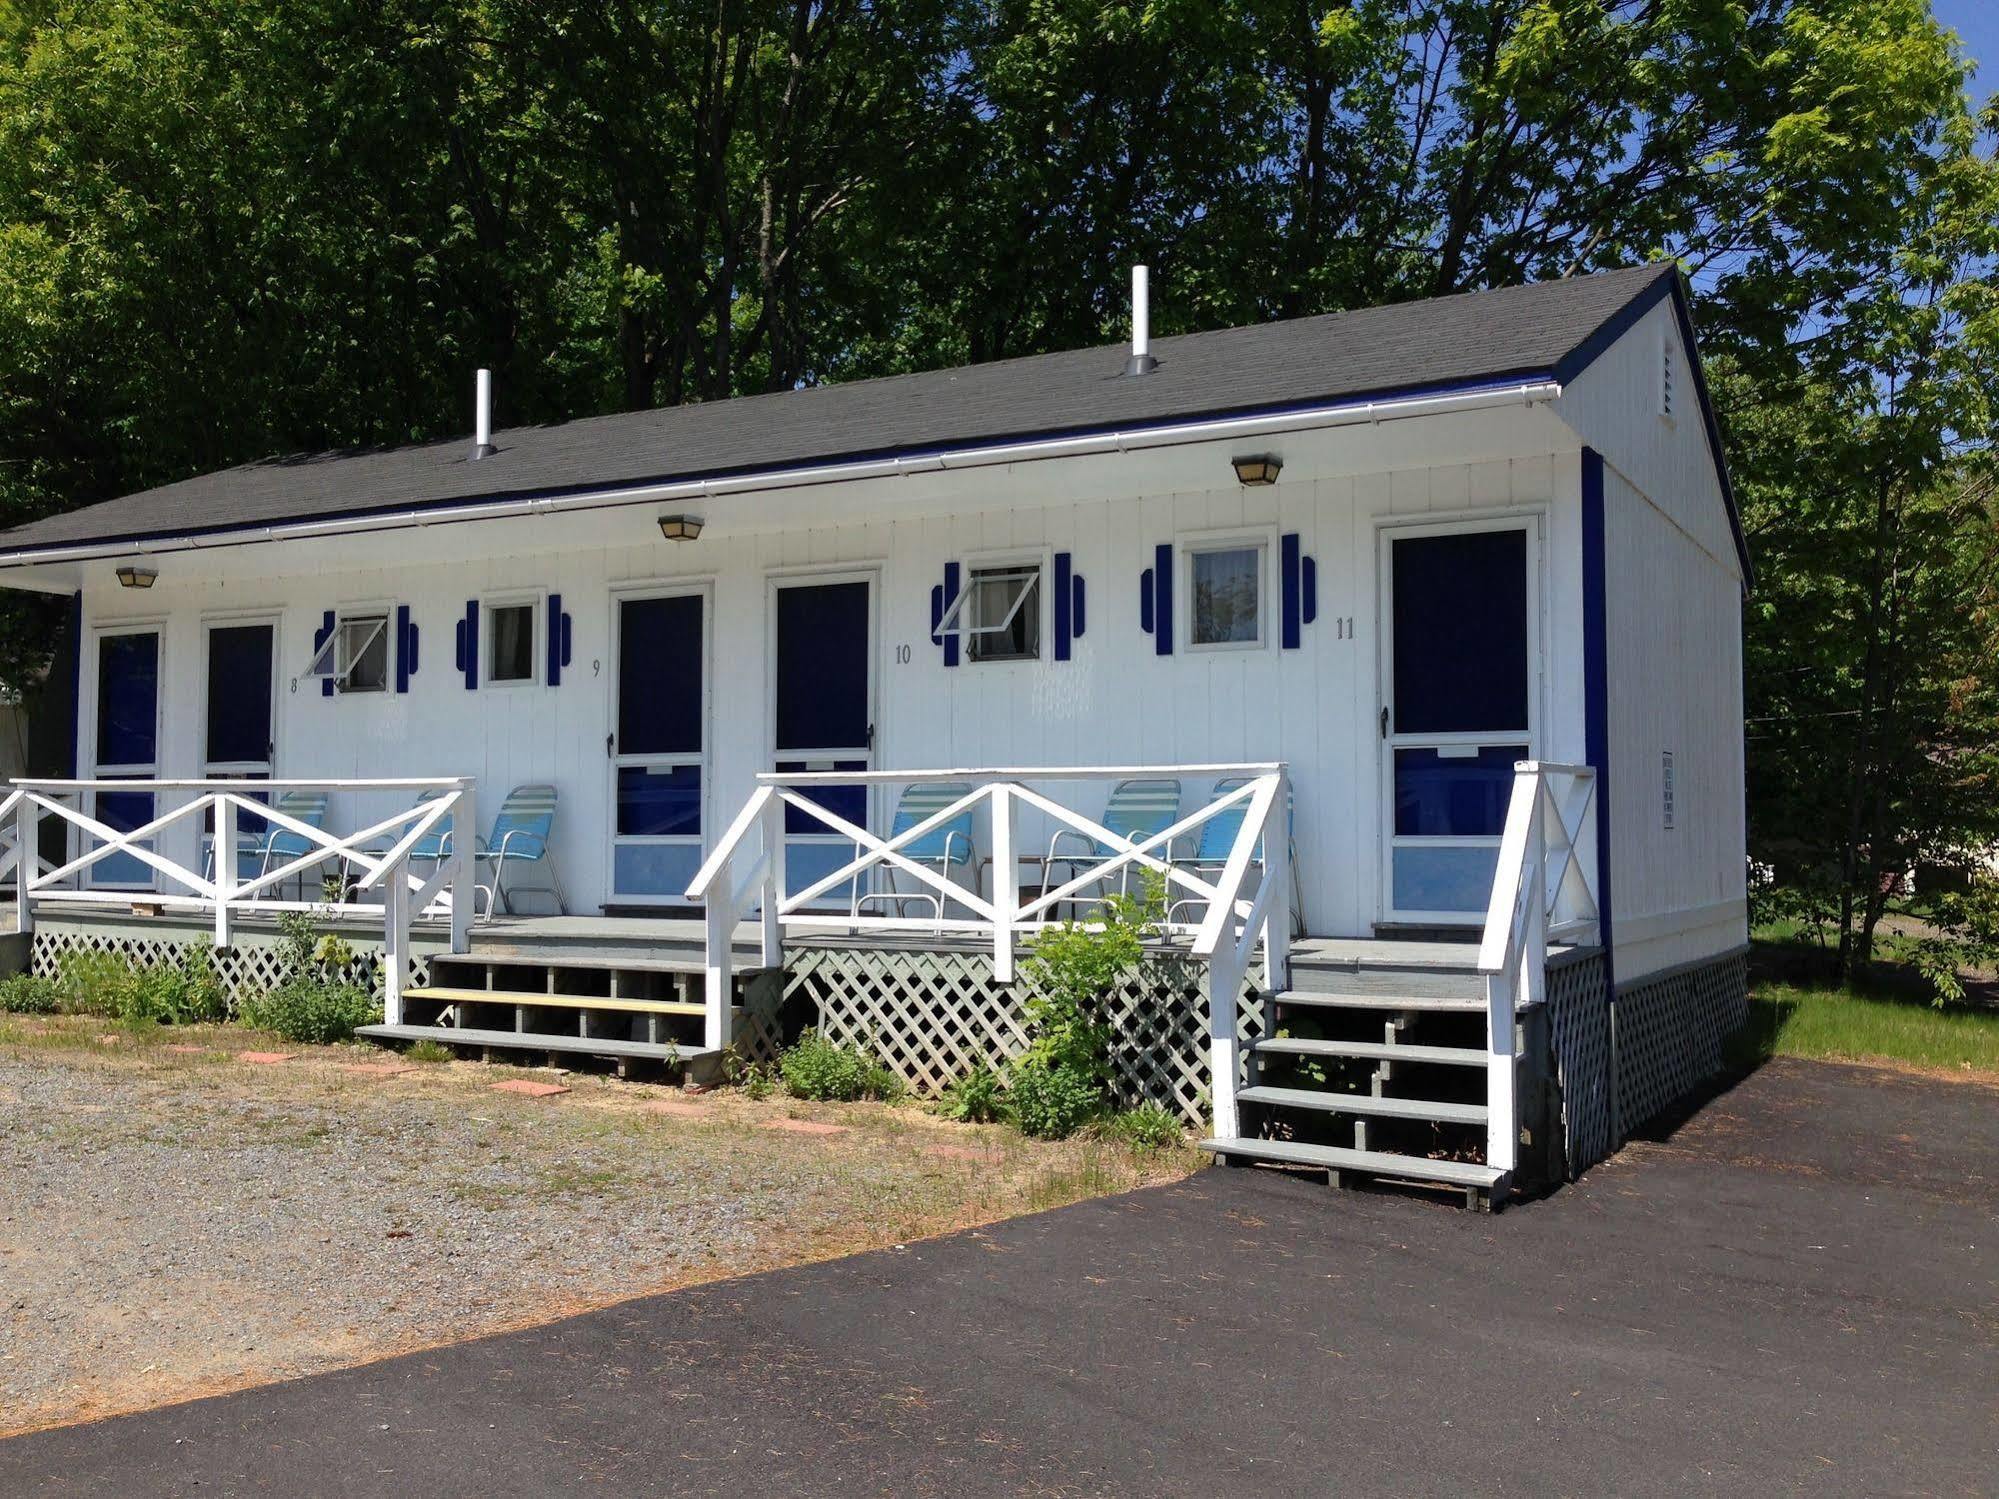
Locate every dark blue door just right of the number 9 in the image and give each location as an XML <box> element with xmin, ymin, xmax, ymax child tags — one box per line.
<box><xmin>606</xmin><ymin>590</ymin><xmax>708</xmax><ymax>905</ymax></box>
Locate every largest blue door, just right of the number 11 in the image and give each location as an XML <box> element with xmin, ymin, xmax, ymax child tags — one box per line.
<box><xmin>1381</xmin><ymin>520</ymin><xmax>1539</xmax><ymax>923</ymax></box>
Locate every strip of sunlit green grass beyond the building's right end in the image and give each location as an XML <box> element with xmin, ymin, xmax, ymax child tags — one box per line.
<box><xmin>1735</xmin><ymin>981</ymin><xmax>1999</xmax><ymax>1073</ymax></box>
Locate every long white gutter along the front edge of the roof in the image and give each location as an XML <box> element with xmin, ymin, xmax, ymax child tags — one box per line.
<box><xmin>0</xmin><ymin>380</ymin><xmax>1561</xmax><ymax>568</ymax></box>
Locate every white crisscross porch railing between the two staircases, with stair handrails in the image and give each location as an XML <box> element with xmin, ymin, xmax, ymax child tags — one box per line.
<box><xmin>688</xmin><ymin>763</ymin><xmax>1291</xmax><ymax>1135</ymax></box>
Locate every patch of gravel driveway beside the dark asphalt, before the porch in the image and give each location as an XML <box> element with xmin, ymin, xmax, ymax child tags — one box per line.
<box><xmin>0</xmin><ymin>1021</ymin><xmax>1187</xmax><ymax>1433</ymax></box>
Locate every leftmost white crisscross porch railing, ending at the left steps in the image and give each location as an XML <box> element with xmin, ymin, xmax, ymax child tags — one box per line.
<box><xmin>0</xmin><ymin>777</ymin><xmax>478</xmax><ymax>1023</ymax></box>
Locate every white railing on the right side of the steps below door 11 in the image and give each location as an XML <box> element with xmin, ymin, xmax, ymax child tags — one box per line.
<box><xmin>1479</xmin><ymin>759</ymin><xmax>1599</xmax><ymax>1175</ymax></box>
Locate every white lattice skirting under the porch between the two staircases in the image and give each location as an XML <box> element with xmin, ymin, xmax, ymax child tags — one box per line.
<box><xmin>786</xmin><ymin>947</ymin><xmax>1263</xmax><ymax>1125</ymax></box>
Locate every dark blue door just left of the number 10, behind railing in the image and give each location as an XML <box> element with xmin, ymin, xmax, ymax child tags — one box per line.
<box><xmin>772</xmin><ymin>578</ymin><xmax>874</xmax><ymax>909</ymax></box>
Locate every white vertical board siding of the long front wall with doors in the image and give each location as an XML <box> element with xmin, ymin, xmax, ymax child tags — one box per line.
<box><xmin>82</xmin><ymin>445</ymin><xmax>1607</xmax><ymax>933</ymax></box>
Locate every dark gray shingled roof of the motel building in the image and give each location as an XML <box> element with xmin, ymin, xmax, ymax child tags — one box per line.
<box><xmin>0</xmin><ymin>264</ymin><xmax>1675</xmax><ymax>552</ymax></box>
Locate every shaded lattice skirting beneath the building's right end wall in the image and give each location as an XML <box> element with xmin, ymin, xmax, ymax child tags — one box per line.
<box><xmin>1611</xmin><ymin>953</ymin><xmax>1749</xmax><ymax>1133</ymax></box>
